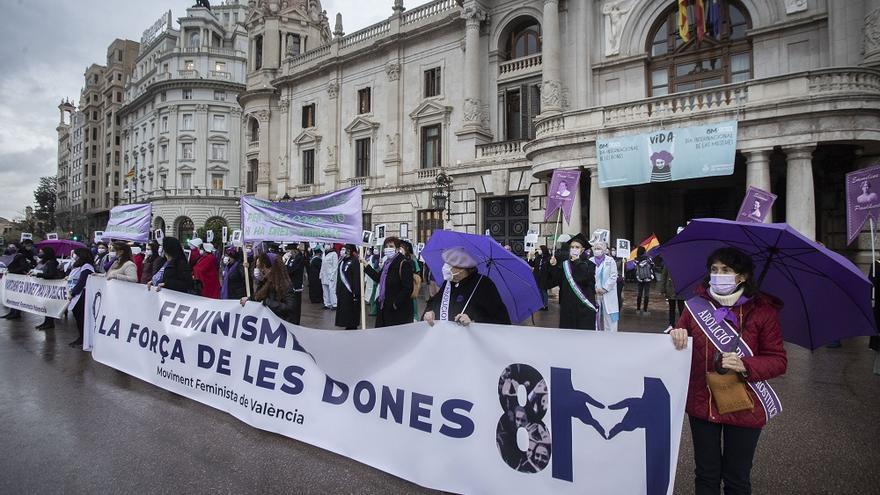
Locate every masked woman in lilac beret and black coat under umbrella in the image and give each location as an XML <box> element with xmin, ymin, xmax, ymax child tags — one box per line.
<box><xmin>422</xmin><ymin>247</ymin><xmax>510</xmax><ymax>326</ymax></box>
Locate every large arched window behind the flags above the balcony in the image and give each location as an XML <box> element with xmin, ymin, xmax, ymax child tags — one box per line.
<box><xmin>646</xmin><ymin>0</ymin><xmax>752</xmax><ymax>96</ymax></box>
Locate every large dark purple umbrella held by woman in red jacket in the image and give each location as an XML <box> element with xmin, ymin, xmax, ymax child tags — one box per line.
<box><xmin>660</xmin><ymin>218</ymin><xmax>877</xmax><ymax>349</ymax></box>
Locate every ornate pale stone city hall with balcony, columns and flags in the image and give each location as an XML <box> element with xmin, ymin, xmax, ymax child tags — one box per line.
<box><xmin>239</xmin><ymin>0</ymin><xmax>880</xmax><ymax>266</ymax></box>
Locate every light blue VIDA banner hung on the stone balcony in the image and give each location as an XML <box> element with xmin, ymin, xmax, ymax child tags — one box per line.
<box><xmin>596</xmin><ymin>120</ymin><xmax>737</xmax><ymax>187</ymax></box>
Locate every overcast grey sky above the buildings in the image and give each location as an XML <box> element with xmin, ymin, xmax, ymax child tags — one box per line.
<box><xmin>0</xmin><ymin>0</ymin><xmax>384</xmax><ymax>219</ymax></box>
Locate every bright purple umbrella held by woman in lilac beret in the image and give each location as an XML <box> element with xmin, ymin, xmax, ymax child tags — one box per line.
<box><xmin>422</xmin><ymin>230</ymin><xmax>544</xmax><ymax>323</ymax></box>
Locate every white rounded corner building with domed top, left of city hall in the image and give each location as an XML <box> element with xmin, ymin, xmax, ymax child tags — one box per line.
<box><xmin>119</xmin><ymin>1</ymin><xmax>247</xmax><ymax>239</ymax></box>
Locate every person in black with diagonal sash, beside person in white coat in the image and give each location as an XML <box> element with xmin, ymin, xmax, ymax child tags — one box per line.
<box><xmin>550</xmin><ymin>234</ymin><xmax>598</xmax><ymax>330</ymax></box>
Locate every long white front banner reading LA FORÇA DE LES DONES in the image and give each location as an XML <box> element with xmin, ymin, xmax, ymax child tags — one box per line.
<box><xmin>86</xmin><ymin>277</ymin><xmax>690</xmax><ymax>495</ymax></box>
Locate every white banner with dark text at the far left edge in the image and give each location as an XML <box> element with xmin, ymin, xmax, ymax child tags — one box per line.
<box><xmin>0</xmin><ymin>273</ymin><xmax>67</xmax><ymax>318</ymax></box>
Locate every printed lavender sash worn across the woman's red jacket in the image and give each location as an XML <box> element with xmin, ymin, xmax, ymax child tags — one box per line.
<box><xmin>684</xmin><ymin>296</ymin><xmax>782</xmax><ymax>421</ymax></box>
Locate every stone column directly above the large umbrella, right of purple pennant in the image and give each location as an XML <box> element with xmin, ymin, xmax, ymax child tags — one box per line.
<box><xmin>785</xmin><ymin>146</ymin><xmax>816</xmax><ymax>240</ymax></box>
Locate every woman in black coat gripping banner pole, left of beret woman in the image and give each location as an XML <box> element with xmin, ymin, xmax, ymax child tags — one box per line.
<box><xmin>361</xmin><ymin>237</ymin><xmax>413</xmax><ymax>328</ymax></box>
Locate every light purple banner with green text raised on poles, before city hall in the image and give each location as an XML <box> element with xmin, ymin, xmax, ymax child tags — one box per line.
<box><xmin>241</xmin><ymin>187</ymin><xmax>363</xmax><ymax>244</ymax></box>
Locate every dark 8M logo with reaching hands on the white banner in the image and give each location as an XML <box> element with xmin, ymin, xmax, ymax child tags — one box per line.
<box><xmin>495</xmin><ymin>363</ymin><xmax>672</xmax><ymax>495</ymax></box>
